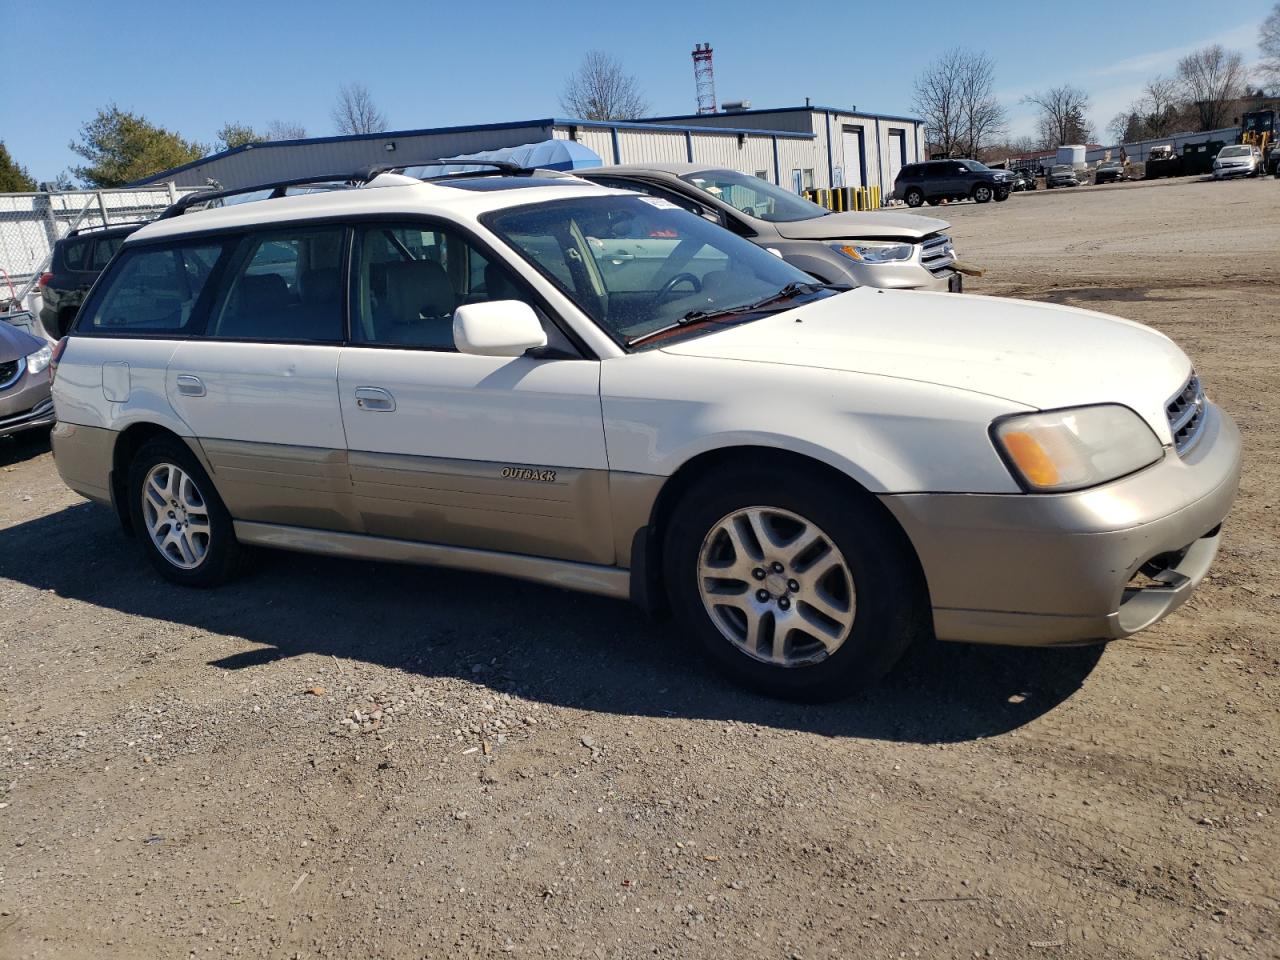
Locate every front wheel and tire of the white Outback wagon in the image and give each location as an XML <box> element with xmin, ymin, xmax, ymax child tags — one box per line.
<box><xmin>663</xmin><ymin>466</ymin><xmax>928</xmax><ymax>701</ymax></box>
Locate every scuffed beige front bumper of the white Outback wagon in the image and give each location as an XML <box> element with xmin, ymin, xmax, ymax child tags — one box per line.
<box><xmin>881</xmin><ymin>404</ymin><xmax>1240</xmax><ymax>646</ymax></box>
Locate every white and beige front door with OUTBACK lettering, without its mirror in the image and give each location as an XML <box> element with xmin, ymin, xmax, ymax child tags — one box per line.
<box><xmin>338</xmin><ymin>220</ymin><xmax>614</xmax><ymax>564</ymax></box>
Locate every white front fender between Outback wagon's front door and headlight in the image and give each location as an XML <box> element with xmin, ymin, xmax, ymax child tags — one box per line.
<box><xmin>602</xmin><ymin>351</ymin><xmax>1028</xmax><ymax>493</ymax></box>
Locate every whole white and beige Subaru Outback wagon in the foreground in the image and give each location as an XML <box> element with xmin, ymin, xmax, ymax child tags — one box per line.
<box><xmin>54</xmin><ymin>172</ymin><xmax>1240</xmax><ymax>699</ymax></box>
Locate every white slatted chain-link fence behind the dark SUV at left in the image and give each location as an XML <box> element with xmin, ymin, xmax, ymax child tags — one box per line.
<box><xmin>0</xmin><ymin>183</ymin><xmax>202</xmax><ymax>308</ymax></box>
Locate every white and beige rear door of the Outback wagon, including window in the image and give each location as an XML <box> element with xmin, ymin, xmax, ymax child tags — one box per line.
<box><xmin>165</xmin><ymin>224</ymin><xmax>360</xmax><ymax>530</ymax></box>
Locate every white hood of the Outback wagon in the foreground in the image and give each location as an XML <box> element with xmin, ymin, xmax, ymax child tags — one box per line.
<box><xmin>663</xmin><ymin>287</ymin><xmax>1192</xmax><ymax>443</ymax></box>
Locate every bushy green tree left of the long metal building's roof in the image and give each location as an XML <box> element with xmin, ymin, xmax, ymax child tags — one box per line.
<box><xmin>70</xmin><ymin>104</ymin><xmax>209</xmax><ymax>187</ymax></box>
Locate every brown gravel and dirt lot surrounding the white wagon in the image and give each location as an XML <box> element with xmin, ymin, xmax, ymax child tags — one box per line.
<box><xmin>0</xmin><ymin>179</ymin><xmax>1280</xmax><ymax>960</ymax></box>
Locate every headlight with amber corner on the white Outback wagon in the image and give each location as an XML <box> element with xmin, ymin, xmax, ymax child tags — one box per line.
<box><xmin>992</xmin><ymin>404</ymin><xmax>1164</xmax><ymax>493</ymax></box>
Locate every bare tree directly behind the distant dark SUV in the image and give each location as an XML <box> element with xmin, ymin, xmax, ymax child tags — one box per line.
<box><xmin>914</xmin><ymin>47</ymin><xmax>1007</xmax><ymax>157</ymax></box>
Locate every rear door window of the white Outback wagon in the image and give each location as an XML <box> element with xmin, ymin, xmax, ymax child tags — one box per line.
<box><xmin>207</xmin><ymin>227</ymin><xmax>344</xmax><ymax>343</ymax></box>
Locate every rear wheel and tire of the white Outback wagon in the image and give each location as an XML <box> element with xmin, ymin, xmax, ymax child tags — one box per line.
<box><xmin>129</xmin><ymin>436</ymin><xmax>241</xmax><ymax>586</ymax></box>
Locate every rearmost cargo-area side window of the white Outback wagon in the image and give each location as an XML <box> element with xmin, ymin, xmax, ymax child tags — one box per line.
<box><xmin>76</xmin><ymin>239</ymin><xmax>223</xmax><ymax>335</ymax></box>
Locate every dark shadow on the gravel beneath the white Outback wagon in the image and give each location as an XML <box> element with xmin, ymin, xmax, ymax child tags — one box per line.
<box><xmin>0</xmin><ymin>504</ymin><xmax>1103</xmax><ymax>742</ymax></box>
